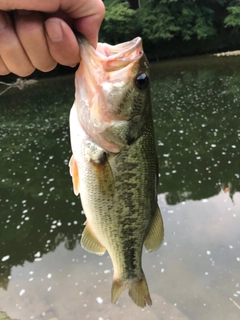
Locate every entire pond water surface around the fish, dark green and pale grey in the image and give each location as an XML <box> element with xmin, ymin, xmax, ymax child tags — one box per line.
<box><xmin>0</xmin><ymin>57</ymin><xmax>240</xmax><ymax>320</ymax></box>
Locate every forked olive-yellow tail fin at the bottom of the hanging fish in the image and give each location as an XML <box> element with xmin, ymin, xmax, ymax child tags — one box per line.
<box><xmin>112</xmin><ymin>275</ymin><xmax>152</xmax><ymax>308</ymax></box>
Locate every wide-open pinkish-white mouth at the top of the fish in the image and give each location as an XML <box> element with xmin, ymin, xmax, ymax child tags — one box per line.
<box><xmin>78</xmin><ymin>36</ymin><xmax>143</xmax><ymax>72</ymax></box>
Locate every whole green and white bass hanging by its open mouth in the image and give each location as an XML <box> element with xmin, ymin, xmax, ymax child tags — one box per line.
<box><xmin>69</xmin><ymin>36</ymin><xmax>164</xmax><ymax>307</ymax></box>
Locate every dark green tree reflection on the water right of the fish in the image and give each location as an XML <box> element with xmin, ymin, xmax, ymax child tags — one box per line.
<box><xmin>152</xmin><ymin>58</ymin><xmax>240</xmax><ymax>204</ymax></box>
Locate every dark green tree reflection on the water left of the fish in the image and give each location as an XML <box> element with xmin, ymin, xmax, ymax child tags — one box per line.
<box><xmin>0</xmin><ymin>78</ymin><xmax>83</xmax><ymax>288</ymax></box>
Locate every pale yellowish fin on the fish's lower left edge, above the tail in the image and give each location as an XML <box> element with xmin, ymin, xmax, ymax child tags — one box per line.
<box><xmin>81</xmin><ymin>224</ymin><xmax>106</xmax><ymax>255</ymax></box>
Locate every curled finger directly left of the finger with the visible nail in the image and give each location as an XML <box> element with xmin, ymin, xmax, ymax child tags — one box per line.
<box><xmin>15</xmin><ymin>11</ymin><xmax>57</xmax><ymax>72</ymax></box>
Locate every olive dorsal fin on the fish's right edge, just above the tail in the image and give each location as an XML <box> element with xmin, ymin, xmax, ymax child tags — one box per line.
<box><xmin>144</xmin><ymin>206</ymin><xmax>164</xmax><ymax>251</ymax></box>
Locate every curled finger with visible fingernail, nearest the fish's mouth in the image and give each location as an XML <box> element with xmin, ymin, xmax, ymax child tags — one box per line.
<box><xmin>45</xmin><ymin>18</ymin><xmax>80</xmax><ymax>66</ymax></box>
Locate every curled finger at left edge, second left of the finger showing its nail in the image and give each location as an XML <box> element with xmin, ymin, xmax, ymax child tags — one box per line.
<box><xmin>0</xmin><ymin>11</ymin><xmax>34</xmax><ymax>77</ymax></box>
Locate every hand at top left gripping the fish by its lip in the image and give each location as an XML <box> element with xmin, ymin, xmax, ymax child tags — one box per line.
<box><xmin>0</xmin><ymin>0</ymin><xmax>105</xmax><ymax>77</ymax></box>
